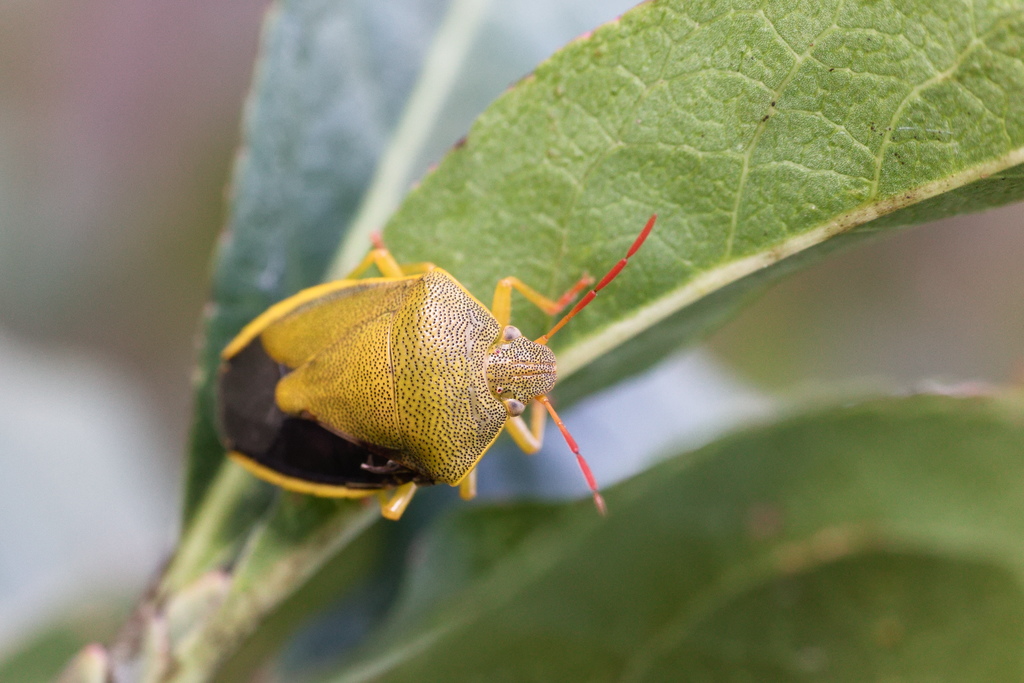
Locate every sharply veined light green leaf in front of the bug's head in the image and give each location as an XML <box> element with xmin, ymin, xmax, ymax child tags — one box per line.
<box><xmin>364</xmin><ymin>0</ymin><xmax>1024</xmax><ymax>396</ymax></box>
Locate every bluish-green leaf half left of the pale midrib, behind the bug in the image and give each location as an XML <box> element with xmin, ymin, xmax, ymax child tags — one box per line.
<box><xmin>184</xmin><ymin>0</ymin><xmax>448</xmax><ymax>523</ymax></box>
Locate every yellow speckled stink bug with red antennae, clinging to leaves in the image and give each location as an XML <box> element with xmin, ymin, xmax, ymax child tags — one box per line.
<box><xmin>219</xmin><ymin>216</ymin><xmax>655</xmax><ymax>519</ymax></box>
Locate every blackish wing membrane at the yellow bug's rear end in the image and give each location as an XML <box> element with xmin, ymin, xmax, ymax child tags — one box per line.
<box><xmin>219</xmin><ymin>337</ymin><xmax>433</xmax><ymax>490</ymax></box>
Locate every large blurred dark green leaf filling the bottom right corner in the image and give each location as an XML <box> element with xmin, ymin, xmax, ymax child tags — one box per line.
<box><xmin>337</xmin><ymin>395</ymin><xmax>1024</xmax><ymax>682</ymax></box>
